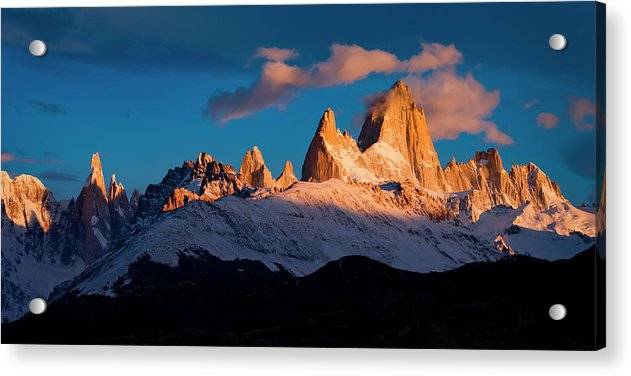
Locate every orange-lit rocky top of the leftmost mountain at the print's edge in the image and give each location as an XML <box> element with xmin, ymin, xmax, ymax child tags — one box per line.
<box><xmin>0</xmin><ymin>171</ymin><xmax>55</xmax><ymax>232</ymax></box>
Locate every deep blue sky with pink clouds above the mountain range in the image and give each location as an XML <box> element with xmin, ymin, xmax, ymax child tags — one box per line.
<box><xmin>1</xmin><ymin>2</ymin><xmax>596</xmax><ymax>203</ymax></box>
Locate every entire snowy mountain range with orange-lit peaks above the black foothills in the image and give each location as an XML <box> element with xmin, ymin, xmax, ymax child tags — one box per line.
<box><xmin>1</xmin><ymin>81</ymin><xmax>597</xmax><ymax>322</ymax></box>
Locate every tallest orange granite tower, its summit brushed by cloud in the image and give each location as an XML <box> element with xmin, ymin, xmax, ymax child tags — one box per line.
<box><xmin>358</xmin><ymin>81</ymin><xmax>448</xmax><ymax>192</ymax></box>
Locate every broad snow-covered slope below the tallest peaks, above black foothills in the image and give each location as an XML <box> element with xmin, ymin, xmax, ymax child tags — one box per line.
<box><xmin>56</xmin><ymin>179</ymin><xmax>589</xmax><ymax>294</ymax></box>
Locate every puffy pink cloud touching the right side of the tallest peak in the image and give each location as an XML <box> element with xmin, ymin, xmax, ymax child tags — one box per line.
<box><xmin>406</xmin><ymin>69</ymin><xmax>513</xmax><ymax>145</ymax></box>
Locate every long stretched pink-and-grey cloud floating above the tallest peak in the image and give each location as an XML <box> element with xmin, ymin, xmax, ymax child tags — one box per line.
<box><xmin>204</xmin><ymin>43</ymin><xmax>462</xmax><ymax>123</ymax></box>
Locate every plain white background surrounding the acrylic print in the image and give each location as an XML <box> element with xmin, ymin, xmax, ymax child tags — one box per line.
<box><xmin>0</xmin><ymin>0</ymin><xmax>631</xmax><ymax>376</ymax></box>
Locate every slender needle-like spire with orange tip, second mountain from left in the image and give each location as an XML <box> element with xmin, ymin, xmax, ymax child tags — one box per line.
<box><xmin>77</xmin><ymin>153</ymin><xmax>112</xmax><ymax>262</ymax></box>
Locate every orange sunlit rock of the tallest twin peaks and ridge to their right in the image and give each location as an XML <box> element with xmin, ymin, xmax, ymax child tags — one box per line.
<box><xmin>302</xmin><ymin>81</ymin><xmax>571</xmax><ymax>225</ymax></box>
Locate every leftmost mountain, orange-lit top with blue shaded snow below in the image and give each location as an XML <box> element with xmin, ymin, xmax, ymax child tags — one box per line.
<box><xmin>0</xmin><ymin>171</ymin><xmax>85</xmax><ymax>322</ymax></box>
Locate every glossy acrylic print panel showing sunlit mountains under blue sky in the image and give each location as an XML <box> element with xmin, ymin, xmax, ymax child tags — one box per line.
<box><xmin>2</xmin><ymin>2</ymin><xmax>605</xmax><ymax>350</ymax></box>
